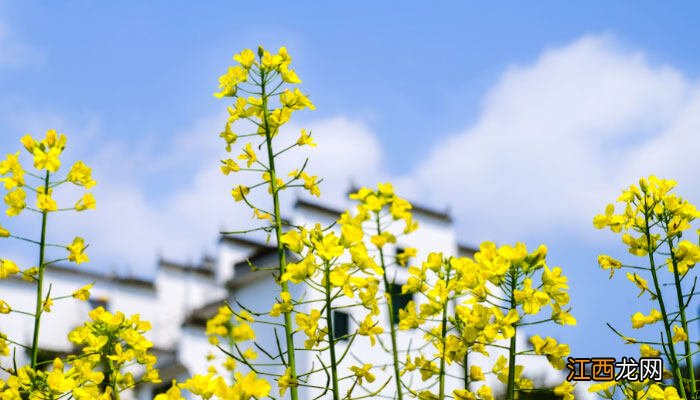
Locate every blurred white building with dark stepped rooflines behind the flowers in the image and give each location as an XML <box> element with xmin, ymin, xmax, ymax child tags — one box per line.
<box><xmin>0</xmin><ymin>193</ymin><xmax>585</xmax><ymax>399</ymax></box>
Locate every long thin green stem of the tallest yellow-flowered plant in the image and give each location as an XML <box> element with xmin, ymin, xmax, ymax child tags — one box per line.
<box><xmin>260</xmin><ymin>66</ymin><xmax>299</xmax><ymax>400</ymax></box>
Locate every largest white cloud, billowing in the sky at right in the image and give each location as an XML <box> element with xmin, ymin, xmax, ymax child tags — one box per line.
<box><xmin>399</xmin><ymin>36</ymin><xmax>700</xmax><ymax>242</ymax></box>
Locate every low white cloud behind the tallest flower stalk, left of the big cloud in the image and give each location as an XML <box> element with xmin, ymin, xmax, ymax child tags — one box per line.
<box><xmin>27</xmin><ymin>115</ymin><xmax>381</xmax><ymax>275</ymax></box>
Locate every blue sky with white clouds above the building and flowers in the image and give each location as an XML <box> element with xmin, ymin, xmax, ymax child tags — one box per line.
<box><xmin>0</xmin><ymin>1</ymin><xmax>700</xmax><ymax>370</ymax></box>
